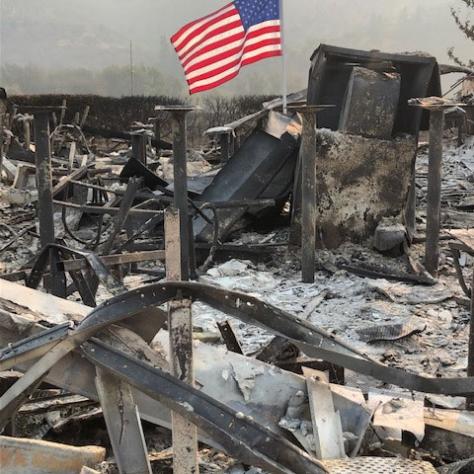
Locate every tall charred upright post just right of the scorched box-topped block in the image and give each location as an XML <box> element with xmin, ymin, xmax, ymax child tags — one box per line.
<box><xmin>425</xmin><ymin>109</ymin><xmax>444</xmax><ymax>277</ymax></box>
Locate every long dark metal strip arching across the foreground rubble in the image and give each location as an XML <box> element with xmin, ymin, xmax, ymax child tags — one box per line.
<box><xmin>3</xmin><ymin>282</ymin><xmax>474</xmax><ymax>396</ymax></box>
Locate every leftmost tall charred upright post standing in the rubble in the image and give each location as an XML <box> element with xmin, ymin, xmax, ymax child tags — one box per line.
<box><xmin>34</xmin><ymin>110</ymin><xmax>65</xmax><ymax>297</ymax></box>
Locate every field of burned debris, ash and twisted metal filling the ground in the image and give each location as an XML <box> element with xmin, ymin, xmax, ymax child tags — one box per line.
<box><xmin>0</xmin><ymin>45</ymin><xmax>474</xmax><ymax>474</ymax></box>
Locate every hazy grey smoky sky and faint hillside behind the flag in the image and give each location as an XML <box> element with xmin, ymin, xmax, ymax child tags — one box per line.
<box><xmin>0</xmin><ymin>0</ymin><xmax>473</xmax><ymax>92</ymax></box>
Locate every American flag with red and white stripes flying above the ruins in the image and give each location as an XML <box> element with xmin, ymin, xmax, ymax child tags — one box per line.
<box><xmin>171</xmin><ymin>0</ymin><xmax>282</xmax><ymax>94</ymax></box>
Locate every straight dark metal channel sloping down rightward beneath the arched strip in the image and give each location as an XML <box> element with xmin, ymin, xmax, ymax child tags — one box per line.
<box><xmin>83</xmin><ymin>340</ymin><xmax>327</xmax><ymax>474</ymax></box>
